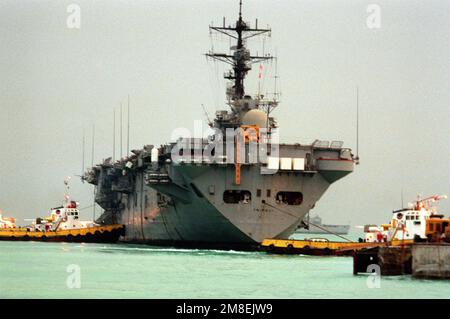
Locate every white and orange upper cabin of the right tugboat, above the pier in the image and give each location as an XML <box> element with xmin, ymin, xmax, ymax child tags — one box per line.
<box><xmin>364</xmin><ymin>195</ymin><xmax>450</xmax><ymax>242</ymax></box>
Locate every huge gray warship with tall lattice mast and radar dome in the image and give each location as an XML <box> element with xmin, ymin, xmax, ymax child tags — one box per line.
<box><xmin>82</xmin><ymin>2</ymin><xmax>357</xmax><ymax>249</ymax></box>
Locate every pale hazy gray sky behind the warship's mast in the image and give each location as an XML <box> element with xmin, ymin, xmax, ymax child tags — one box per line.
<box><xmin>0</xmin><ymin>0</ymin><xmax>450</xmax><ymax>225</ymax></box>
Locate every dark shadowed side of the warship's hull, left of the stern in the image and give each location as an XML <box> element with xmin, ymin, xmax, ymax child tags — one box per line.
<box><xmin>120</xmin><ymin>171</ymin><xmax>252</xmax><ymax>245</ymax></box>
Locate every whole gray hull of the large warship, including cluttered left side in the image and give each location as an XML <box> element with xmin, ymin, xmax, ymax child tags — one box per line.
<box><xmin>92</xmin><ymin>145</ymin><xmax>353</xmax><ymax>249</ymax></box>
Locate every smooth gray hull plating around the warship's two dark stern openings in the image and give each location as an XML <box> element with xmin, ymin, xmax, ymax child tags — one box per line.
<box><xmin>120</xmin><ymin>165</ymin><xmax>329</xmax><ymax>245</ymax></box>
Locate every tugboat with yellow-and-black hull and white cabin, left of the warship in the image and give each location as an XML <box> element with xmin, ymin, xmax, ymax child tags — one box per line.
<box><xmin>0</xmin><ymin>179</ymin><xmax>124</xmax><ymax>243</ymax></box>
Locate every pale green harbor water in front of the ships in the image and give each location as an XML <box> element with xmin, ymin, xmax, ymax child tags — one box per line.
<box><xmin>0</xmin><ymin>242</ymin><xmax>450</xmax><ymax>298</ymax></box>
